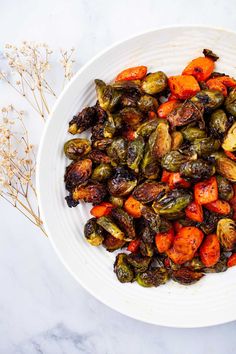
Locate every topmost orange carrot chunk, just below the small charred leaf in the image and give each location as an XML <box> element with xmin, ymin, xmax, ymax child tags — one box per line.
<box><xmin>182</xmin><ymin>57</ymin><xmax>215</xmax><ymax>81</ymax></box>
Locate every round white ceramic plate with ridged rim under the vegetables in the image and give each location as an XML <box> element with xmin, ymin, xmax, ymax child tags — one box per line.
<box><xmin>37</xmin><ymin>27</ymin><xmax>236</xmax><ymax>327</ymax></box>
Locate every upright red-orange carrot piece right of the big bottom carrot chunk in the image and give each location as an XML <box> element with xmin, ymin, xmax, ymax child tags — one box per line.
<box><xmin>199</xmin><ymin>234</ymin><xmax>220</xmax><ymax>267</ymax></box>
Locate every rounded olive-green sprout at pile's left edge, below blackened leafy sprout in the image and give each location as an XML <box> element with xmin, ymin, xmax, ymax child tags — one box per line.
<box><xmin>64</xmin><ymin>138</ymin><xmax>91</xmax><ymax>160</ymax></box>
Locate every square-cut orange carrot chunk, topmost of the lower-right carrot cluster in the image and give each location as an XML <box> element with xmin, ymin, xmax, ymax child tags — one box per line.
<box><xmin>194</xmin><ymin>176</ymin><xmax>218</xmax><ymax>205</ymax></box>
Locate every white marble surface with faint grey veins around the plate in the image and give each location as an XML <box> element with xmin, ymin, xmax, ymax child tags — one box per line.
<box><xmin>0</xmin><ymin>0</ymin><xmax>236</xmax><ymax>354</ymax></box>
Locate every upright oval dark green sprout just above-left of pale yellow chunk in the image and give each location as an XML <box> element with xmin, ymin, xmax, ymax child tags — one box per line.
<box><xmin>209</xmin><ymin>109</ymin><xmax>230</xmax><ymax>138</ymax></box>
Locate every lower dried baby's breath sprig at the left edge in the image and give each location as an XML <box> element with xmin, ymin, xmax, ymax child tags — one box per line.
<box><xmin>0</xmin><ymin>106</ymin><xmax>46</xmax><ymax>235</ymax></box>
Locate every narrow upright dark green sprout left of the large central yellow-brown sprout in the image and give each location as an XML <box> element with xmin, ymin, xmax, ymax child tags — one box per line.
<box><xmin>127</xmin><ymin>136</ymin><xmax>145</xmax><ymax>173</ymax></box>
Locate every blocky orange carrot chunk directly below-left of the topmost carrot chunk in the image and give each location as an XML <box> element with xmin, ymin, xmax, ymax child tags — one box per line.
<box><xmin>168</xmin><ymin>75</ymin><xmax>200</xmax><ymax>100</ymax></box>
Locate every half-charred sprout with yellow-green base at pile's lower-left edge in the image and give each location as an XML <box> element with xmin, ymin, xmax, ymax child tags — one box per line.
<box><xmin>84</xmin><ymin>218</ymin><xmax>104</xmax><ymax>246</ymax></box>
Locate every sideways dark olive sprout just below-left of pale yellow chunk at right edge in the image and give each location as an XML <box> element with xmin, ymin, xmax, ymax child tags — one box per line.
<box><xmin>190</xmin><ymin>137</ymin><xmax>221</xmax><ymax>157</ymax></box>
